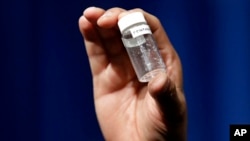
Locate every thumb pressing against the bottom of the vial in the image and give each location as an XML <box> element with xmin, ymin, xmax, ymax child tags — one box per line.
<box><xmin>148</xmin><ymin>73</ymin><xmax>187</xmax><ymax>128</ymax></box>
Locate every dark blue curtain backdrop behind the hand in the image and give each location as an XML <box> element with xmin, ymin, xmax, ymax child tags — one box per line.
<box><xmin>0</xmin><ymin>0</ymin><xmax>250</xmax><ymax>141</ymax></box>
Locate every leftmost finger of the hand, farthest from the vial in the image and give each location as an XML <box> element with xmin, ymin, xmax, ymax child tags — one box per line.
<box><xmin>79</xmin><ymin>7</ymin><xmax>112</xmax><ymax>75</ymax></box>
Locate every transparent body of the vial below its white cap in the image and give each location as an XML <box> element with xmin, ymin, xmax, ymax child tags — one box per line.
<box><xmin>122</xmin><ymin>24</ymin><xmax>166</xmax><ymax>82</ymax></box>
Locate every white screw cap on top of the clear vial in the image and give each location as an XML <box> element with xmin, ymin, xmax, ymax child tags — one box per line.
<box><xmin>118</xmin><ymin>12</ymin><xmax>146</xmax><ymax>32</ymax></box>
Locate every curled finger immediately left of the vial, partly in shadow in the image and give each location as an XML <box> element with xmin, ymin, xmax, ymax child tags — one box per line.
<box><xmin>94</xmin><ymin>7</ymin><xmax>135</xmax><ymax>82</ymax></box>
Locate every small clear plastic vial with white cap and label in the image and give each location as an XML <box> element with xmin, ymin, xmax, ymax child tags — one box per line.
<box><xmin>118</xmin><ymin>12</ymin><xmax>166</xmax><ymax>82</ymax></box>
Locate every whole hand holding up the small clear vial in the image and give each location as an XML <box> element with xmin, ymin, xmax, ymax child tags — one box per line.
<box><xmin>79</xmin><ymin>7</ymin><xmax>187</xmax><ymax>141</ymax></box>
